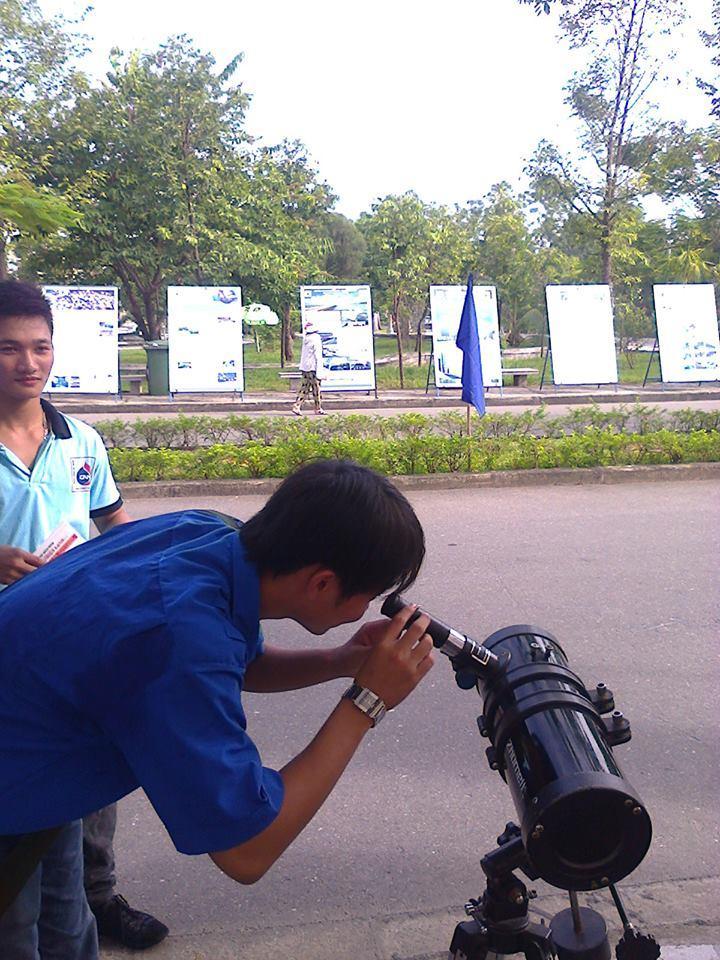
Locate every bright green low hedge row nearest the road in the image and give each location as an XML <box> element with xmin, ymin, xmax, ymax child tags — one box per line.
<box><xmin>110</xmin><ymin>427</ymin><xmax>720</xmax><ymax>482</ymax></box>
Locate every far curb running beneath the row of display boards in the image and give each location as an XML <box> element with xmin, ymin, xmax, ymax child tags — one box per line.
<box><xmin>47</xmin><ymin>387</ymin><xmax>720</xmax><ymax>414</ymax></box>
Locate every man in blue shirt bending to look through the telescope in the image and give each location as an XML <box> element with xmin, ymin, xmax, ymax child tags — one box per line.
<box><xmin>0</xmin><ymin>461</ymin><xmax>433</xmax><ymax>960</ymax></box>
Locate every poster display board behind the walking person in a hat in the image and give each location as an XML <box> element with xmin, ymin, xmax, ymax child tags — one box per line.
<box><xmin>300</xmin><ymin>286</ymin><xmax>375</xmax><ymax>390</ymax></box>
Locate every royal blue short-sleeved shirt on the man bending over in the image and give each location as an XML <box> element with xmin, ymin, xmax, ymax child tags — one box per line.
<box><xmin>0</xmin><ymin>510</ymin><xmax>283</xmax><ymax>854</ymax></box>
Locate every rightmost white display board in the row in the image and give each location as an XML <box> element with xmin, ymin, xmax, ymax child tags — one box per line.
<box><xmin>653</xmin><ymin>283</ymin><xmax>720</xmax><ymax>383</ymax></box>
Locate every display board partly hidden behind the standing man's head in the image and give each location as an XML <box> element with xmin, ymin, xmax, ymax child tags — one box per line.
<box><xmin>42</xmin><ymin>286</ymin><xmax>119</xmax><ymax>393</ymax></box>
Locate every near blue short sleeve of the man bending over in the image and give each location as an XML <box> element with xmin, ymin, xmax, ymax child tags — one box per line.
<box><xmin>107</xmin><ymin>640</ymin><xmax>283</xmax><ymax>854</ymax></box>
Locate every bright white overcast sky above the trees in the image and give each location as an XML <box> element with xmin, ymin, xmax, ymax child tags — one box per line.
<box><xmin>41</xmin><ymin>0</ymin><xmax>711</xmax><ymax>217</ymax></box>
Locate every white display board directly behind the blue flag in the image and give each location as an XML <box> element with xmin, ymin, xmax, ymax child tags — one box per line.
<box><xmin>430</xmin><ymin>285</ymin><xmax>502</xmax><ymax>387</ymax></box>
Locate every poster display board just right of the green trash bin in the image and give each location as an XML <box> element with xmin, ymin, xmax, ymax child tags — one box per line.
<box><xmin>168</xmin><ymin>287</ymin><xmax>244</xmax><ymax>393</ymax></box>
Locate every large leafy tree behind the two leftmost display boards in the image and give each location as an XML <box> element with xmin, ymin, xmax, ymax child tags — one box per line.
<box><xmin>19</xmin><ymin>37</ymin><xmax>253</xmax><ymax>339</ymax></box>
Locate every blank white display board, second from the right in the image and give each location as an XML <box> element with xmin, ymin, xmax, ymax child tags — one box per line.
<box><xmin>545</xmin><ymin>284</ymin><xmax>618</xmax><ymax>384</ymax></box>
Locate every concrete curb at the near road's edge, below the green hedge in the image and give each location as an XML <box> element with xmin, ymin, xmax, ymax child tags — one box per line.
<box><xmin>121</xmin><ymin>463</ymin><xmax>720</xmax><ymax>500</ymax></box>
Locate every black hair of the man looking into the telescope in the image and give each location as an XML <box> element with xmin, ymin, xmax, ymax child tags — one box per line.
<box><xmin>240</xmin><ymin>460</ymin><xmax>425</xmax><ymax>597</ymax></box>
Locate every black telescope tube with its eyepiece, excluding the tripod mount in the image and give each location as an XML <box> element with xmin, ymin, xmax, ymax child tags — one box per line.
<box><xmin>382</xmin><ymin>595</ymin><xmax>652</xmax><ymax>891</ymax></box>
